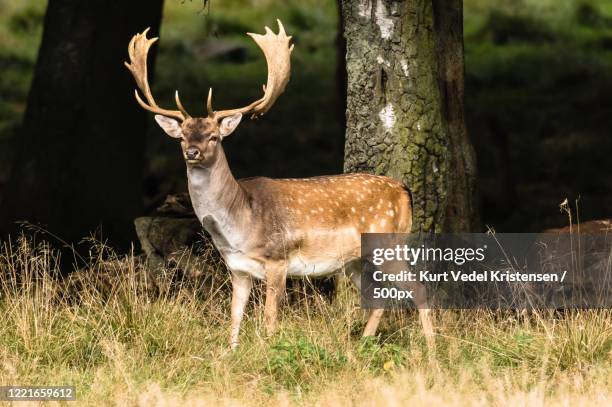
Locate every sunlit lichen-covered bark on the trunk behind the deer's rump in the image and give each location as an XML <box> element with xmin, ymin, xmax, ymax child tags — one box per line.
<box><xmin>341</xmin><ymin>0</ymin><xmax>476</xmax><ymax>232</ymax></box>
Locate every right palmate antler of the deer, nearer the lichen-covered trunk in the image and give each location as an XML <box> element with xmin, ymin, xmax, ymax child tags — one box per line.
<box><xmin>206</xmin><ymin>19</ymin><xmax>293</xmax><ymax>120</ymax></box>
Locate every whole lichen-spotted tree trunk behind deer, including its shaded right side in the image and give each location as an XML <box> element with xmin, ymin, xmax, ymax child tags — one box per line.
<box><xmin>342</xmin><ymin>0</ymin><xmax>477</xmax><ymax>232</ymax></box>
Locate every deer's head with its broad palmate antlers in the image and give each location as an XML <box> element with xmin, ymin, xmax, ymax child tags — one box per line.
<box><xmin>125</xmin><ymin>20</ymin><xmax>293</xmax><ymax>166</ymax></box>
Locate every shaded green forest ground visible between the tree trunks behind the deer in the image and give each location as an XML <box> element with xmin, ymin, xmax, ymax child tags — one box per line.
<box><xmin>0</xmin><ymin>0</ymin><xmax>612</xmax><ymax>232</ymax></box>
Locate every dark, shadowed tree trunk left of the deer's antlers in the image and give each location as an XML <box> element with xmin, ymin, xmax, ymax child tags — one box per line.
<box><xmin>0</xmin><ymin>0</ymin><xmax>163</xmax><ymax>247</ymax></box>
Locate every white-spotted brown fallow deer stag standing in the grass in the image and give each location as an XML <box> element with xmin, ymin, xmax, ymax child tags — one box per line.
<box><xmin>125</xmin><ymin>20</ymin><xmax>432</xmax><ymax>348</ymax></box>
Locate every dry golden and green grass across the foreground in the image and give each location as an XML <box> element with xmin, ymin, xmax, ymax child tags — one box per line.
<box><xmin>0</xmin><ymin>239</ymin><xmax>612</xmax><ymax>406</ymax></box>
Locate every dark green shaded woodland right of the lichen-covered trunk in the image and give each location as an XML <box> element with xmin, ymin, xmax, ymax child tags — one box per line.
<box><xmin>465</xmin><ymin>0</ymin><xmax>612</xmax><ymax>231</ymax></box>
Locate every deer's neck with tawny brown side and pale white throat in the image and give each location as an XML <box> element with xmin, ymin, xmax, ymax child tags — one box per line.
<box><xmin>187</xmin><ymin>146</ymin><xmax>251</xmax><ymax>251</ymax></box>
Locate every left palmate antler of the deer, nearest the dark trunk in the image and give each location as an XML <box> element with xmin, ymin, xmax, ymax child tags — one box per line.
<box><xmin>124</xmin><ymin>28</ymin><xmax>190</xmax><ymax>121</ymax></box>
